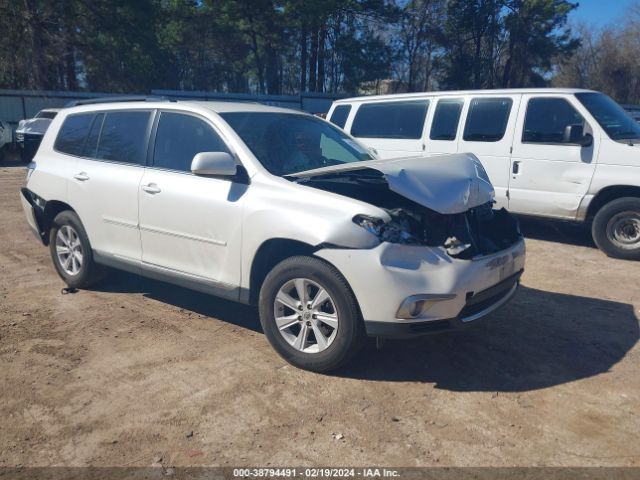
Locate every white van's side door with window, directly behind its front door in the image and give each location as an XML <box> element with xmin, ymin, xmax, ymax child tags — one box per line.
<box><xmin>458</xmin><ymin>95</ymin><xmax>521</xmax><ymax>207</ymax></box>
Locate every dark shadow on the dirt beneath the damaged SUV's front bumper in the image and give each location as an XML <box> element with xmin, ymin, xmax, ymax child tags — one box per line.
<box><xmin>338</xmin><ymin>286</ymin><xmax>639</xmax><ymax>392</ymax></box>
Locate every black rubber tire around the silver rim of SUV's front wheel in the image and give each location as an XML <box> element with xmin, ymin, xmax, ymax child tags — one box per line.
<box><xmin>259</xmin><ymin>256</ymin><xmax>365</xmax><ymax>373</ymax></box>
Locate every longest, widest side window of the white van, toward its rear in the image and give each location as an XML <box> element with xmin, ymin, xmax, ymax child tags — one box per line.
<box><xmin>351</xmin><ymin>100</ymin><xmax>429</xmax><ymax>139</ymax></box>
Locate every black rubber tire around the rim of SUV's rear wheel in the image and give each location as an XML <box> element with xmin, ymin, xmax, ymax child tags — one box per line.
<box><xmin>49</xmin><ymin>210</ymin><xmax>105</xmax><ymax>288</ymax></box>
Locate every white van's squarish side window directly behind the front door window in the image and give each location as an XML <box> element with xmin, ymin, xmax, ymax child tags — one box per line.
<box><xmin>463</xmin><ymin>98</ymin><xmax>513</xmax><ymax>142</ymax></box>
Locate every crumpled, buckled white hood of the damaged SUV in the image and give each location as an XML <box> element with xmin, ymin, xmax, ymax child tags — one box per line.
<box><xmin>292</xmin><ymin>153</ymin><xmax>495</xmax><ymax>214</ymax></box>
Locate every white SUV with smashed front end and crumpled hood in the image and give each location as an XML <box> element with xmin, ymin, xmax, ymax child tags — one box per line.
<box><xmin>22</xmin><ymin>99</ymin><xmax>525</xmax><ymax>371</ymax></box>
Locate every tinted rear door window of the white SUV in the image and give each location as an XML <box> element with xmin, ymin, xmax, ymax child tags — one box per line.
<box><xmin>96</xmin><ymin>111</ymin><xmax>151</xmax><ymax>165</ymax></box>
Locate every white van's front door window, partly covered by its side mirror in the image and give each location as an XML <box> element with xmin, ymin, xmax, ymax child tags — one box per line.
<box><xmin>522</xmin><ymin>98</ymin><xmax>584</xmax><ymax>143</ymax></box>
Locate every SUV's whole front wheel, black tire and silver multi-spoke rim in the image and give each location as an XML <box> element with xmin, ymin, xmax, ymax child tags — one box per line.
<box><xmin>259</xmin><ymin>256</ymin><xmax>365</xmax><ymax>372</ymax></box>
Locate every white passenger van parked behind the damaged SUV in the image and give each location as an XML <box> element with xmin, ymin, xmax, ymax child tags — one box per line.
<box><xmin>327</xmin><ymin>89</ymin><xmax>640</xmax><ymax>259</ymax></box>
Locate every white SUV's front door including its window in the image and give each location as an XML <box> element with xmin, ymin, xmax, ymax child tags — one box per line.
<box><xmin>139</xmin><ymin>111</ymin><xmax>247</xmax><ymax>288</ymax></box>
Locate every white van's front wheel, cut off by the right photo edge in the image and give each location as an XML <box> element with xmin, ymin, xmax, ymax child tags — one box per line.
<box><xmin>591</xmin><ymin>197</ymin><xmax>640</xmax><ymax>260</ymax></box>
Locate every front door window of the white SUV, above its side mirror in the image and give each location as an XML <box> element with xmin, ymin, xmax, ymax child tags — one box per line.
<box><xmin>153</xmin><ymin>112</ymin><xmax>229</xmax><ymax>172</ymax></box>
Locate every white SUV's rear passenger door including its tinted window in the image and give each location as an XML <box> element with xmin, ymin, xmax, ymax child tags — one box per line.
<box><xmin>69</xmin><ymin>110</ymin><xmax>152</xmax><ymax>262</ymax></box>
